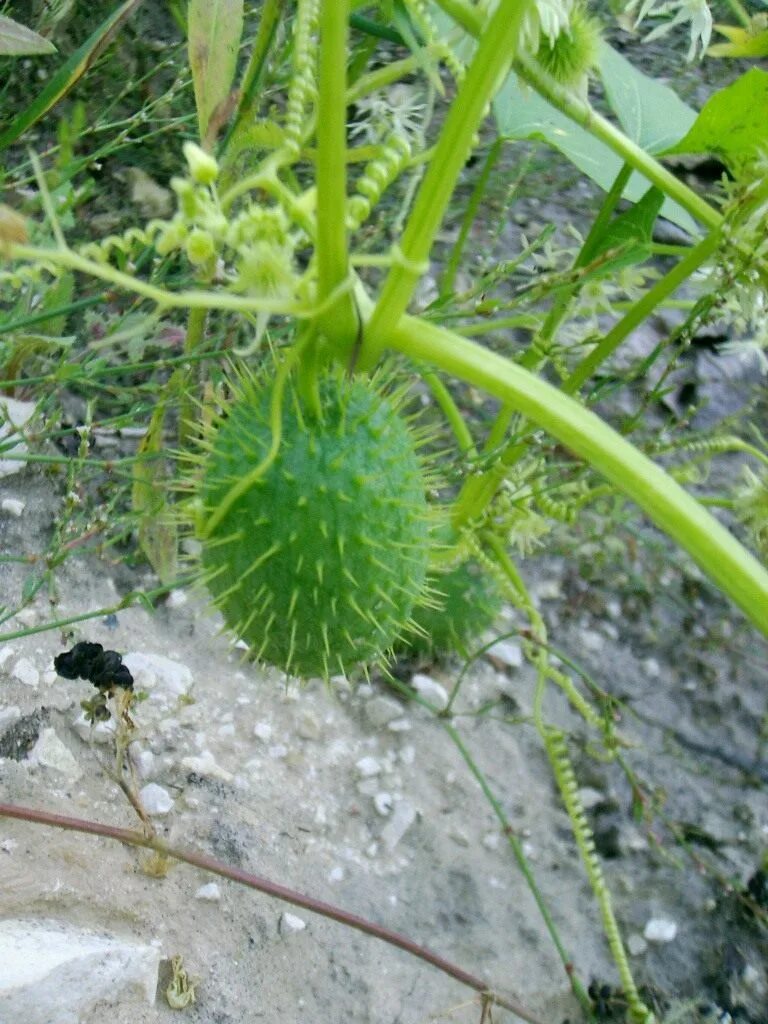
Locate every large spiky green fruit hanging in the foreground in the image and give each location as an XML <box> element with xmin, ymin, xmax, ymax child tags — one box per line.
<box><xmin>201</xmin><ymin>374</ymin><xmax>430</xmax><ymax>677</ymax></box>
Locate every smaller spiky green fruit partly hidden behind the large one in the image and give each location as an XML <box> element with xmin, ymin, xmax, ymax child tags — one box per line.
<box><xmin>406</xmin><ymin>561</ymin><xmax>502</xmax><ymax>655</ymax></box>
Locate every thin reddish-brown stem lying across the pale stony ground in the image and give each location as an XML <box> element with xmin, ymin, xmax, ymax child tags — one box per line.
<box><xmin>0</xmin><ymin>803</ymin><xmax>543</xmax><ymax>1024</ymax></box>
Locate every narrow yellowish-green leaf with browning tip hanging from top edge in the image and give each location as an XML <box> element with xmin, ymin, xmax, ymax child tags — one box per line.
<box><xmin>187</xmin><ymin>0</ymin><xmax>243</xmax><ymax>147</ymax></box>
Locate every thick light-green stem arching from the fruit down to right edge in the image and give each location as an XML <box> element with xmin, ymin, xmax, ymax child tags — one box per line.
<box><xmin>388</xmin><ymin>316</ymin><xmax>768</xmax><ymax>636</ymax></box>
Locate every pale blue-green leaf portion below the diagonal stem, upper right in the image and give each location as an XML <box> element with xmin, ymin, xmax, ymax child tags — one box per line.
<box><xmin>494</xmin><ymin>75</ymin><xmax>698</xmax><ymax>234</ymax></box>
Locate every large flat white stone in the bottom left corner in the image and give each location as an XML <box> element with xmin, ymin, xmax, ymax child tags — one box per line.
<box><xmin>0</xmin><ymin>920</ymin><xmax>160</xmax><ymax>1024</ymax></box>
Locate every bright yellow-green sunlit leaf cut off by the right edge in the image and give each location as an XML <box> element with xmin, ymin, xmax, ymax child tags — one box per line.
<box><xmin>667</xmin><ymin>68</ymin><xmax>768</xmax><ymax>174</ymax></box>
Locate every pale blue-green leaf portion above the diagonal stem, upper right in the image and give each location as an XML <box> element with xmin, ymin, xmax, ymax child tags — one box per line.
<box><xmin>599</xmin><ymin>43</ymin><xmax>696</xmax><ymax>154</ymax></box>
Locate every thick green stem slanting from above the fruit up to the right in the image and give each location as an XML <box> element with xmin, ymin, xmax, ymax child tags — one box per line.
<box><xmin>364</xmin><ymin>0</ymin><xmax>527</xmax><ymax>366</ymax></box>
